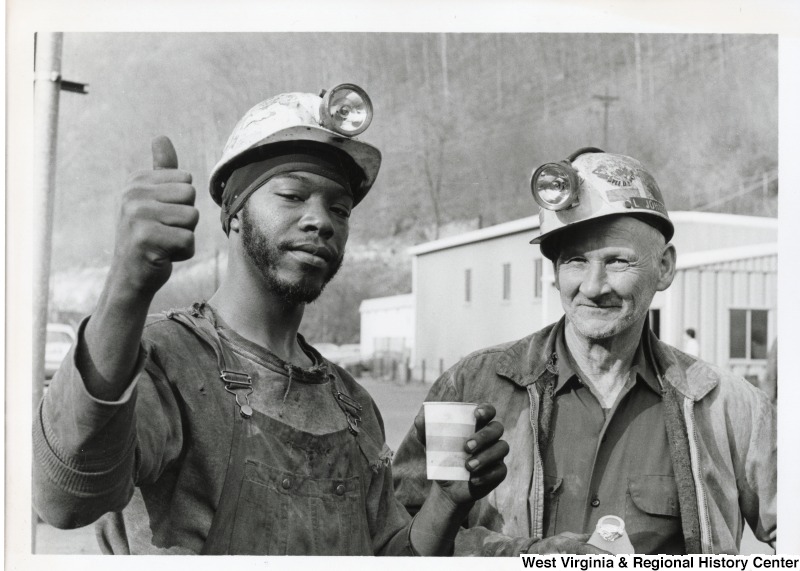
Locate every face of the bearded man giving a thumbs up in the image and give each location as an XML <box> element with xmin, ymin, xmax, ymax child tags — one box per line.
<box><xmin>241</xmin><ymin>172</ymin><xmax>353</xmax><ymax>305</ymax></box>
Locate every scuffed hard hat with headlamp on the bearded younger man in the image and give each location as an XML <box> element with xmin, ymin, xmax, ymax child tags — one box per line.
<box><xmin>209</xmin><ymin>84</ymin><xmax>381</xmax><ymax>209</ymax></box>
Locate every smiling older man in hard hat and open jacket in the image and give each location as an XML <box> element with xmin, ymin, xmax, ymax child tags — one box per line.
<box><xmin>394</xmin><ymin>148</ymin><xmax>776</xmax><ymax>555</ymax></box>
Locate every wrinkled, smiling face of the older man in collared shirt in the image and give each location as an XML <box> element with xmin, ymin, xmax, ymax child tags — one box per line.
<box><xmin>554</xmin><ymin>216</ymin><xmax>675</xmax><ymax>340</ymax></box>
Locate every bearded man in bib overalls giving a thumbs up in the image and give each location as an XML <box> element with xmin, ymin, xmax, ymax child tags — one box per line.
<box><xmin>33</xmin><ymin>85</ymin><xmax>508</xmax><ymax>555</ymax></box>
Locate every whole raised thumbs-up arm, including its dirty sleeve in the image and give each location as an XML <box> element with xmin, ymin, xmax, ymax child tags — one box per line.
<box><xmin>33</xmin><ymin>137</ymin><xmax>198</xmax><ymax>528</ymax></box>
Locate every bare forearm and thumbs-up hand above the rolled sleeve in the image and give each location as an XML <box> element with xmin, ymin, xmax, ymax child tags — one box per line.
<box><xmin>77</xmin><ymin>137</ymin><xmax>199</xmax><ymax>400</ymax></box>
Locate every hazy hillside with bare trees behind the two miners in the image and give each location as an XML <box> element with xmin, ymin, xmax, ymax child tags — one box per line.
<box><xmin>47</xmin><ymin>33</ymin><xmax>778</xmax><ymax>343</ymax></box>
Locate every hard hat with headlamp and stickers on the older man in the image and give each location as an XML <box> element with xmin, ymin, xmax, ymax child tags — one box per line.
<box><xmin>531</xmin><ymin>148</ymin><xmax>675</xmax><ymax>259</ymax></box>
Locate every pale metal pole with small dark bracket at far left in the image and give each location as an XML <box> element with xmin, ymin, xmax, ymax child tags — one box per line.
<box><xmin>31</xmin><ymin>32</ymin><xmax>86</xmax><ymax>553</ymax></box>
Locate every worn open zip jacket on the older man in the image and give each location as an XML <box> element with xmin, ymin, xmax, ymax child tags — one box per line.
<box><xmin>394</xmin><ymin>318</ymin><xmax>776</xmax><ymax>556</ymax></box>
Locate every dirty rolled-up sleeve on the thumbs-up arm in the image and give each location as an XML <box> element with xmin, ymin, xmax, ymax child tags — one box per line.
<box><xmin>33</xmin><ymin>322</ymin><xmax>182</xmax><ymax>529</ymax></box>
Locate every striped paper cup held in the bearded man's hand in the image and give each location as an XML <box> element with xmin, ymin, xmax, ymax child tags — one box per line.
<box><xmin>423</xmin><ymin>402</ymin><xmax>478</xmax><ymax>481</ymax></box>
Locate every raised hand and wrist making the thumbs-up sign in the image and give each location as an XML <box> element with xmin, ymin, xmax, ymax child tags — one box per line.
<box><xmin>108</xmin><ymin>136</ymin><xmax>199</xmax><ymax>301</ymax></box>
